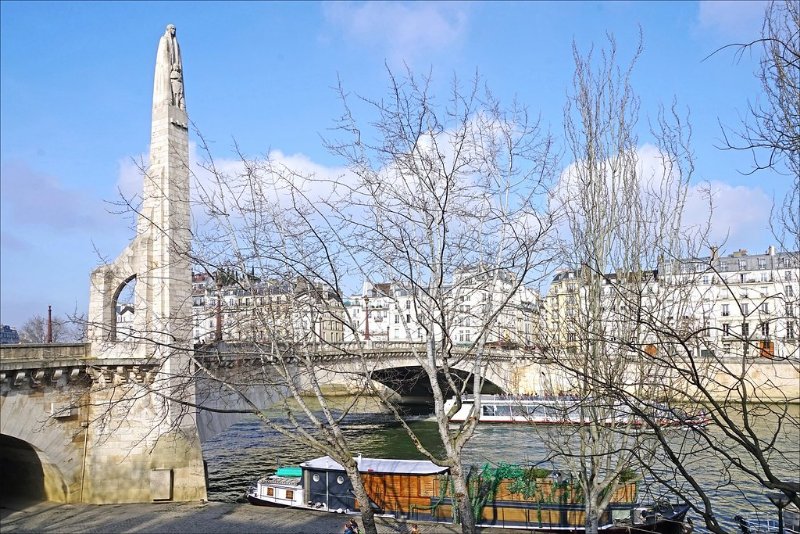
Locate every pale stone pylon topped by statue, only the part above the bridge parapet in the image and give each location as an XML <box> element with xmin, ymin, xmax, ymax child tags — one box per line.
<box><xmin>88</xmin><ymin>25</ymin><xmax>192</xmax><ymax>364</ymax></box>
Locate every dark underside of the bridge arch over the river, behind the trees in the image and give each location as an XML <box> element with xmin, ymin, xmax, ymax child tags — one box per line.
<box><xmin>371</xmin><ymin>367</ymin><xmax>503</xmax><ymax>405</ymax></box>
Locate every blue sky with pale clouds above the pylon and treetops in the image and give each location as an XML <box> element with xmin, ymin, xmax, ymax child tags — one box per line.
<box><xmin>0</xmin><ymin>1</ymin><xmax>787</xmax><ymax>327</ymax></box>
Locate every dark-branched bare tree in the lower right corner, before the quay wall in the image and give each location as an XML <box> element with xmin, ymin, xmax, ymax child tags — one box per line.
<box><xmin>608</xmin><ymin>248</ymin><xmax>800</xmax><ymax>532</ymax></box>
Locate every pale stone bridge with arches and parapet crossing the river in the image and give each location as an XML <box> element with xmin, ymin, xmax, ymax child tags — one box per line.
<box><xmin>0</xmin><ymin>343</ymin><xmax>544</xmax><ymax>503</ymax></box>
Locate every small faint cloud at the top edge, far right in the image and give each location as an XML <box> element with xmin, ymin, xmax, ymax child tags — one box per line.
<box><xmin>698</xmin><ymin>0</ymin><xmax>767</xmax><ymax>42</ymax></box>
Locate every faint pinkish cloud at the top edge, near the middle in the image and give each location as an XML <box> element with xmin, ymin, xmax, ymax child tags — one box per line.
<box><xmin>324</xmin><ymin>2</ymin><xmax>468</xmax><ymax>63</ymax></box>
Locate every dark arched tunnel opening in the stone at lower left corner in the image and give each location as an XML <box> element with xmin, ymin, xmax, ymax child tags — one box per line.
<box><xmin>0</xmin><ymin>434</ymin><xmax>66</xmax><ymax>508</ymax></box>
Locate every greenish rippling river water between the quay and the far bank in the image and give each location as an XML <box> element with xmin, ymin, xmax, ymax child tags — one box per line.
<box><xmin>203</xmin><ymin>407</ymin><xmax>800</xmax><ymax>530</ymax></box>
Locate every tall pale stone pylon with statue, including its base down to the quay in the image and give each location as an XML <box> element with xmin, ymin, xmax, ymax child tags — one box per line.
<box><xmin>84</xmin><ymin>25</ymin><xmax>206</xmax><ymax>502</ymax></box>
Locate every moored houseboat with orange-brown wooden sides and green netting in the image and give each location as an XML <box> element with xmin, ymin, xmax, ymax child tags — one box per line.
<box><xmin>247</xmin><ymin>456</ymin><xmax>689</xmax><ymax>534</ymax></box>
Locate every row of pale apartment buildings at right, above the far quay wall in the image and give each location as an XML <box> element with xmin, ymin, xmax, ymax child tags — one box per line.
<box><xmin>543</xmin><ymin>247</ymin><xmax>800</xmax><ymax>364</ymax></box>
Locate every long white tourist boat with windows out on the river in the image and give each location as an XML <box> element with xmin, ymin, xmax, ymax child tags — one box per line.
<box><xmin>444</xmin><ymin>395</ymin><xmax>709</xmax><ymax>427</ymax></box>
